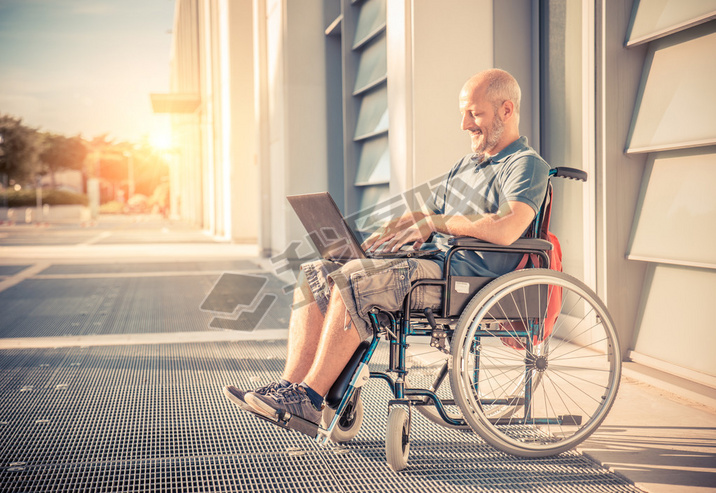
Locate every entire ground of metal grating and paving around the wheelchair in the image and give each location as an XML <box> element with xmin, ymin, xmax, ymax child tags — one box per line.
<box><xmin>0</xmin><ymin>217</ymin><xmax>716</xmax><ymax>492</ymax></box>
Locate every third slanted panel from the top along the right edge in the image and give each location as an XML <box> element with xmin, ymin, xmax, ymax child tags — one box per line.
<box><xmin>629</xmin><ymin>147</ymin><xmax>716</xmax><ymax>269</ymax></box>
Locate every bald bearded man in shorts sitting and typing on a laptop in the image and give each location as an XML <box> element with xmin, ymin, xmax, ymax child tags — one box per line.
<box><xmin>224</xmin><ymin>69</ymin><xmax>549</xmax><ymax>423</ymax></box>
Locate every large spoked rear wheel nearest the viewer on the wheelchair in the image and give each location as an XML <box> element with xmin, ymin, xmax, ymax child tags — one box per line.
<box><xmin>450</xmin><ymin>269</ymin><xmax>621</xmax><ymax>457</ymax></box>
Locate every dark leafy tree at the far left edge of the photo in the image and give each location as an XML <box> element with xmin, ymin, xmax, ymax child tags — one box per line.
<box><xmin>0</xmin><ymin>115</ymin><xmax>43</xmax><ymax>182</ymax></box>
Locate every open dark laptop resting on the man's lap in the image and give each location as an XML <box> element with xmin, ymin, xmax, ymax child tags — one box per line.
<box><xmin>286</xmin><ymin>192</ymin><xmax>439</xmax><ymax>261</ymax></box>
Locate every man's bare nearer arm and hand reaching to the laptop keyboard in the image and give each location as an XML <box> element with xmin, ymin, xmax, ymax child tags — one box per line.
<box><xmin>366</xmin><ymin>201</ymin><xmax>535</xmax><ymax>251</ymax></box>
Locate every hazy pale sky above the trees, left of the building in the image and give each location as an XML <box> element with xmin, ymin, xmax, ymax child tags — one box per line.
<box><xmin>0</xmin><ymin>0</ymin><xmax>174</xmax><ymax>142</ymax></box>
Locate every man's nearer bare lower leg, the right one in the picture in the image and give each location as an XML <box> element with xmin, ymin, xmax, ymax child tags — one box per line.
<box><xmin>302</xmin><ymin>287</ymin><xmax>361</xmax><ymax>396</ymax></box>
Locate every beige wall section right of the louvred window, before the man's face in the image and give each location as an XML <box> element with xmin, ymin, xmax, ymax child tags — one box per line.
<box><xmin>387</xmin><ymin>0</ymin><xmax>493</xmax><ymax>198</ymax></box>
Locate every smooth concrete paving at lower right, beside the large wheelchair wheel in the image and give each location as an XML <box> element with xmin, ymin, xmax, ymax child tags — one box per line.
<box><xmin>580</xmin><ymin>365</ymin><xmax>716</xmax><ymax>493</ymax></box>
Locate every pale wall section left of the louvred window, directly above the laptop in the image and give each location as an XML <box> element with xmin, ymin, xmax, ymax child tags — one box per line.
<box><xmin>258</xmin><ymin>0</ymin><xmax>328</xmax><ymax>253</ymax></box>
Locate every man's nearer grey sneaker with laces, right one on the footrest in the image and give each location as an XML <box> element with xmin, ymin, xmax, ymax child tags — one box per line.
<box><xmin>246</xmin><ymin>383</ymin><xmax>323</xmax><ymax>424</ymax></box>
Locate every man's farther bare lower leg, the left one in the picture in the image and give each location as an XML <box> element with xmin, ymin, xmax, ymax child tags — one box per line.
<box><xmin>281</xmin><ymin>282</ymin><xmax>323</xmax><ymax>383</ymax></box>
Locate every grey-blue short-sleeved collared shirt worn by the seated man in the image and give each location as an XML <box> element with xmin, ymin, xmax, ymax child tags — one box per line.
<box><xmin>425</xmin><ymin>137</ymin><xmax>550</xmax><ymax>277</ymax></box>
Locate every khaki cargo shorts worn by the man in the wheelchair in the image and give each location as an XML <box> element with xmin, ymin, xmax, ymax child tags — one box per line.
<box><xmin>299</xmin><ymin>258</ymin><xmax>443</xmax><ymax>340</ymax></box>
